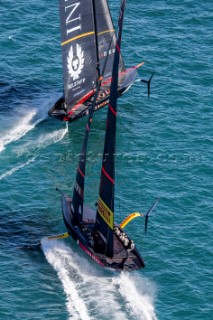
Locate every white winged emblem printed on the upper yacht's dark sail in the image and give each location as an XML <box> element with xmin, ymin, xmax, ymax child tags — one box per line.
<box><xmin>67</xmin><ymin>44</ymin><xmax>84</xmax><ymax>80</ymax></box>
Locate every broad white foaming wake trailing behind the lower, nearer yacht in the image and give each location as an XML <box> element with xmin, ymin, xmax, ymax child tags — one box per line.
<box><xmin>42</xmin><ymin>239</ymin><xmax>157</xmax><ymax>320</ymax></box>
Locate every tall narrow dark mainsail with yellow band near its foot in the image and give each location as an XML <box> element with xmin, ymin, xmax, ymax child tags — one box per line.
<box><xmin>96</xmin><ymin>0</ymin><xmax>125</xmax><ymax>257</ymax></box>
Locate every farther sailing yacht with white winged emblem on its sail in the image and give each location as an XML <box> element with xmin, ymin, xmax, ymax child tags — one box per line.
<box><xmin>49</xmin><ymin>0</ymin><xmax>143</xmax><ymax>122</ymax></box>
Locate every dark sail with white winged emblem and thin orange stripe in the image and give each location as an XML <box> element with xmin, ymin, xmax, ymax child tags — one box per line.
<box><xmin>59</xmin><ymin>0</ymin><xmax>96</xmax><ymax>108</ymax></box>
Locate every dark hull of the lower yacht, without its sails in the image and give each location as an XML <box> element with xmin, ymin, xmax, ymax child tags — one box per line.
<box><xmin>62</xmin><ymin>194</ymin><xmax>145</xmax><ymax>271</ymax></box>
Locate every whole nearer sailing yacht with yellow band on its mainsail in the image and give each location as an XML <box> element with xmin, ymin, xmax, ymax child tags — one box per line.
<box><xmin>55</xmin><ymin>0</ymin><xmax>148</xmax><ymax>271</ymax></box>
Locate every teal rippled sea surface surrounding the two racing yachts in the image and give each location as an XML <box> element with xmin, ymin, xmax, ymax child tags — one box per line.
<box><xmin>0</xmin><ymin>0</ymin><xmax>213</xmax><ymax>320</ymax></box>
